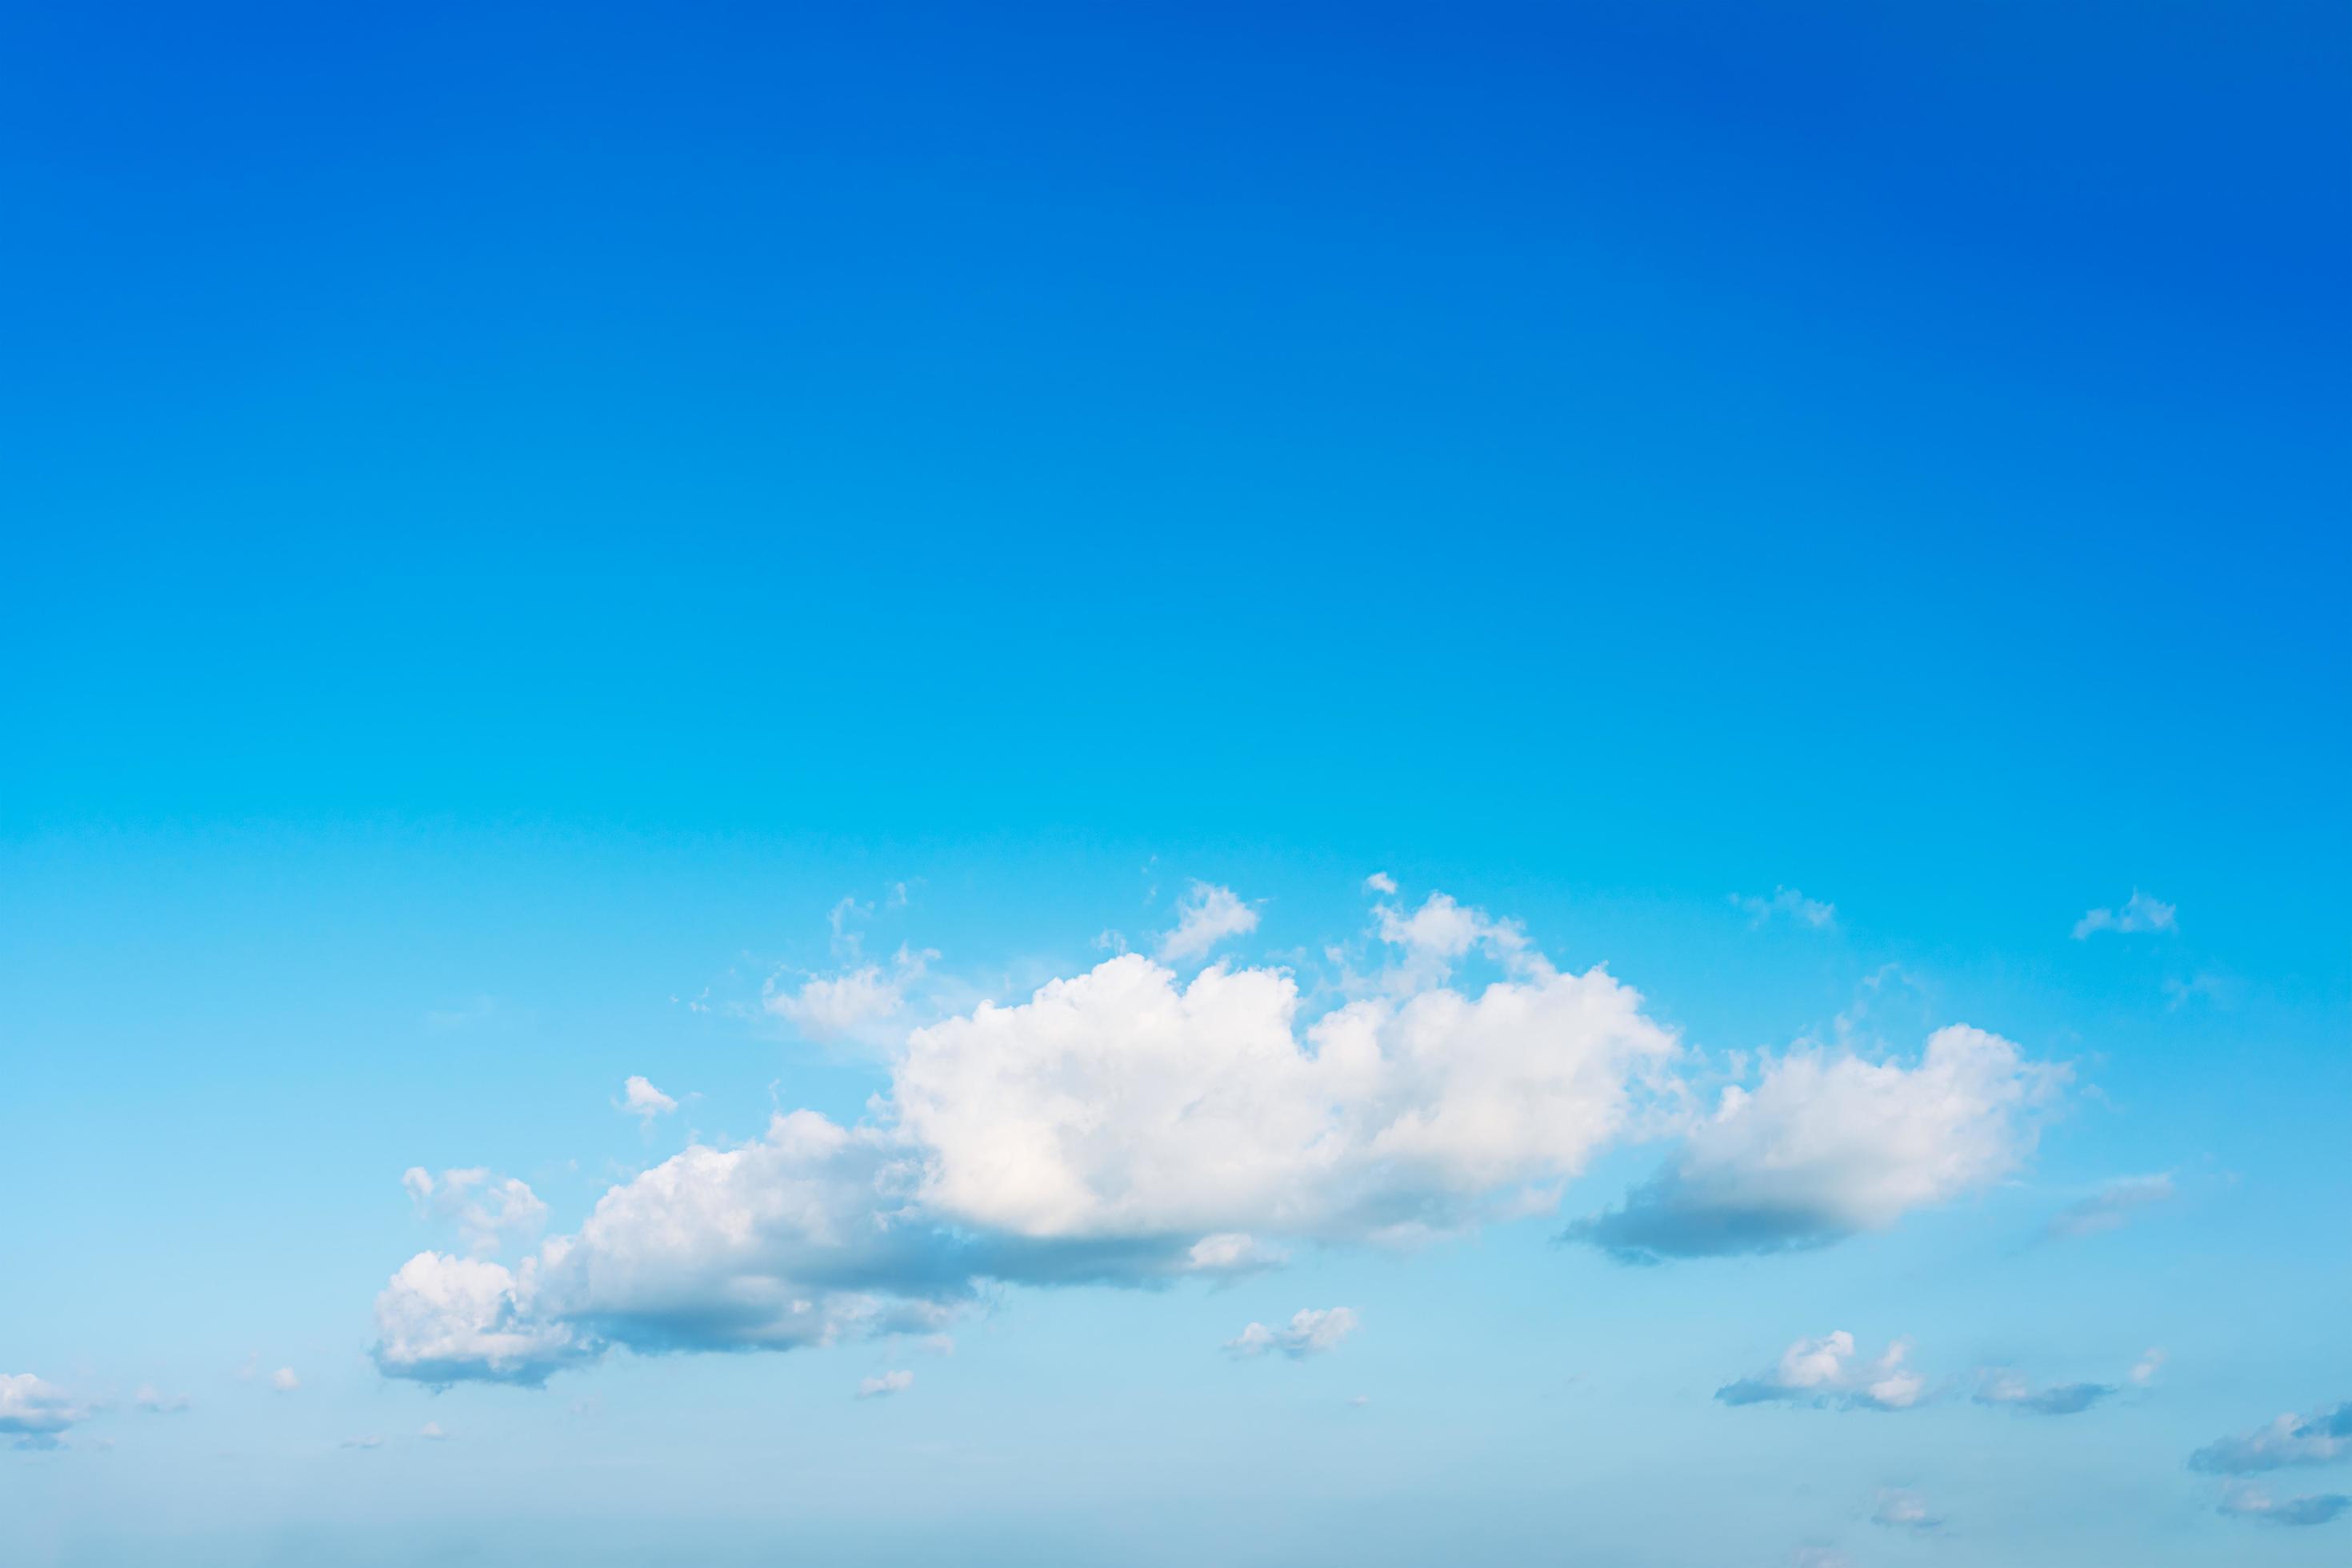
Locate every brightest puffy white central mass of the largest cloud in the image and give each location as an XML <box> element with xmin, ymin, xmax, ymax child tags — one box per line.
<box><xmin>894</xmin><ymin>954</ymin><xmax>1674</xmax><ymax>1246</ymax></box>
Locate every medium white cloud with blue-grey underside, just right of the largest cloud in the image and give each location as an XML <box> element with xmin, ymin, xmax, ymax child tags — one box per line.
<box><xmin>1569</xmin><ymin>1025</ymin><xmax>2067</xmax><ymax>1262</ymax></box>
